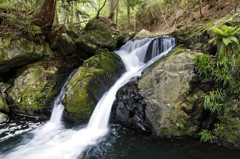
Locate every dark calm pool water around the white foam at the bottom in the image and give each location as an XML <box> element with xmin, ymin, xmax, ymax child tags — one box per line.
<box><xmin>0</xmin><ymin>122</ymin><xmax>240</xmax><ymax>159</ymax></box>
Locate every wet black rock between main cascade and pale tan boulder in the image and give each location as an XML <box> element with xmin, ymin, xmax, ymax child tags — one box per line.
<box><xmin>111</xmin><ymin>80</ymin><xmax>151</xmax><ymax>134</ymax></box>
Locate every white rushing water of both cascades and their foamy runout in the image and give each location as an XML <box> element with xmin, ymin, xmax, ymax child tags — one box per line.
<box><xmin>0</xmin><ymin>37</ymin><xmax>175</xmax><ymax>159</ymax></box>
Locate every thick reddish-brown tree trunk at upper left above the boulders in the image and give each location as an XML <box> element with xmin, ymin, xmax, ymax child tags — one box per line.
<box><xmin>33</xmin><ymin>0</ymin><xmax>57</xmax><ymax>30</ymax></box>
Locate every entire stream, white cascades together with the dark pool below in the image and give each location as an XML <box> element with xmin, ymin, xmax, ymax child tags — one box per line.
<box><xmin>0</xmin><ymin>36</ymin><xmax>240</xmax><ymax>159</ymax></box>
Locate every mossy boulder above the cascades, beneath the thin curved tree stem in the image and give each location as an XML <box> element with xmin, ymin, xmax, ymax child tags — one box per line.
<box><xmin>76</xmin><ymin>18</ymin><xmax>122</xmax><ymax>55</ymax></box>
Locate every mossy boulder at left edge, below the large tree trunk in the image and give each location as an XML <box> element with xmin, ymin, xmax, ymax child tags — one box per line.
<box><xmin>0</xmin><ymin>36</ymin><xmax>52</xmax><ymax>73</ymax></box>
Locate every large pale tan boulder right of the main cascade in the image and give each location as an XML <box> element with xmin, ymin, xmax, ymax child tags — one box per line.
<box><xmin>138</xmin><ymin>48</ymin><xmax>200</xmax><ymax>138</ymax></box>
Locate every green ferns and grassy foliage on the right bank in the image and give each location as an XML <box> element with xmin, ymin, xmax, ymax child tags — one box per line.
<box><xmin>195</xmin><ymin>26</ymin><xmax>240</xmax><ymax>142</ymax></box>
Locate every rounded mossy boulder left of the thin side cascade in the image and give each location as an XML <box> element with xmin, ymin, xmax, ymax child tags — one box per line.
<box><xmin>7</xmin><ymin>60</ymin><xmax>58</xmax><ymax>116</ymax></box>
